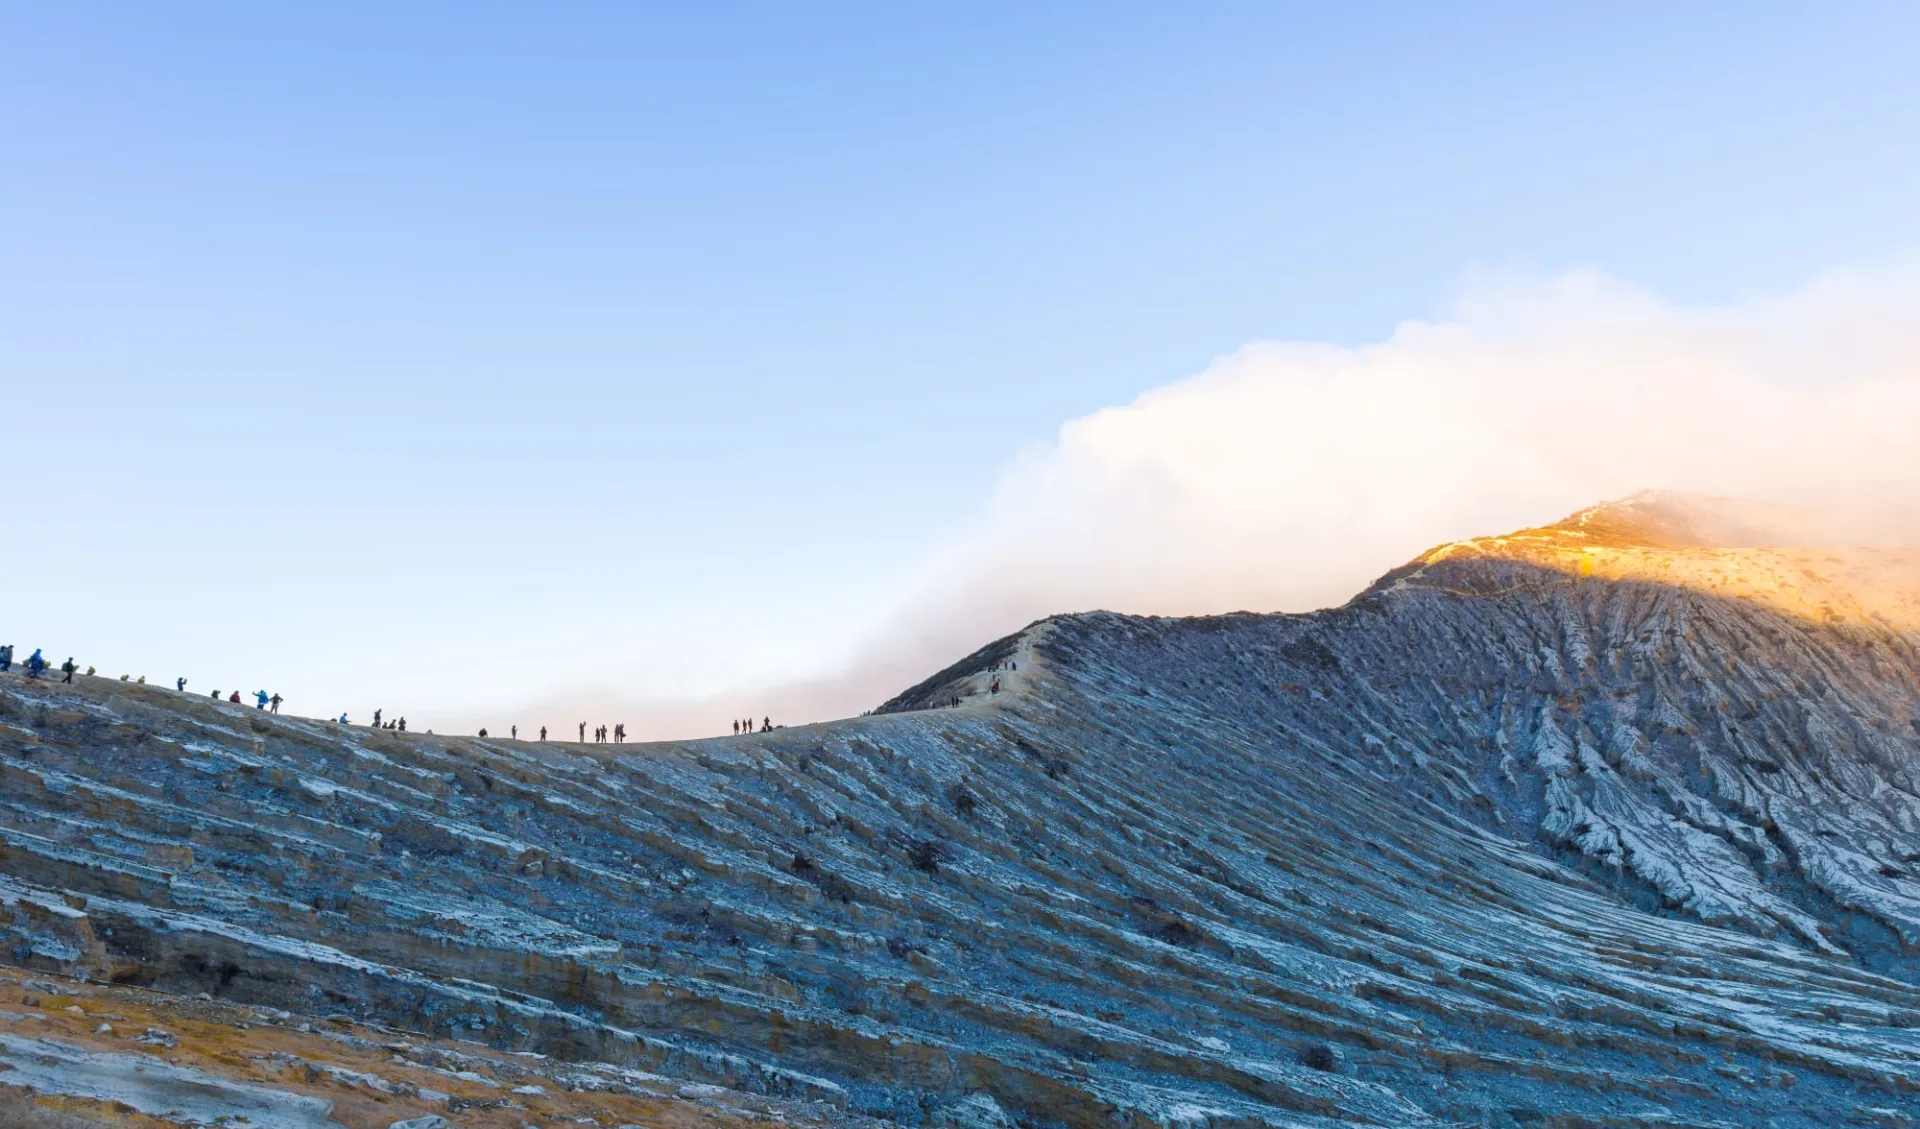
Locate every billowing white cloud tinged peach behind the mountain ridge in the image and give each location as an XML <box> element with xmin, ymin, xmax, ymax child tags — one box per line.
<box><xmin>518</xmin><ymin>267</ymin><xmax>1920</xmax><ymax>732</ymax></box>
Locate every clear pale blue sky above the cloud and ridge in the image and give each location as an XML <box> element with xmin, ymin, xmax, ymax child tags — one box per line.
<box><xmin>0</xmin><ymin>4</ymin><xmax>1920</xmax><ymax>733</ymax></box>
